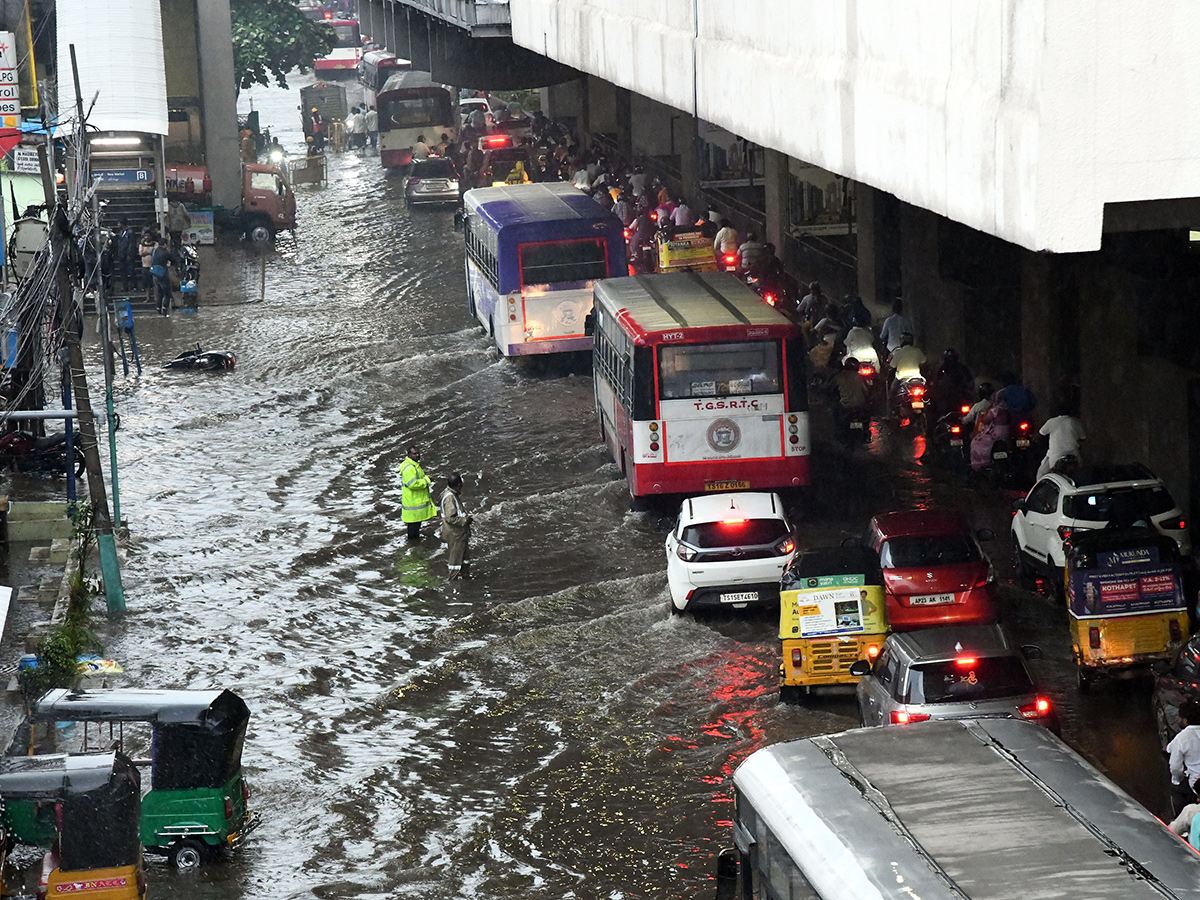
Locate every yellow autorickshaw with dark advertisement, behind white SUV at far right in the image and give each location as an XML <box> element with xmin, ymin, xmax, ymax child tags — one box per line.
<box><xmin>1063</xmin><ymin>528</ymin><xmax>1188</xmax><ymax>691</ymax></box>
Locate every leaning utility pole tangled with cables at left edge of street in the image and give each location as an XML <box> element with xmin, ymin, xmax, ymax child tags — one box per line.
<box><xmin>61</xmin><ymin>44</ymin><xmax>125</xmax><ymax>616</ymax></box>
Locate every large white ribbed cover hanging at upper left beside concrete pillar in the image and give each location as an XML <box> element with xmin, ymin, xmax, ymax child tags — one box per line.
<box><xmin>56</xmin><ymin>0</ymin><xmax>167</xmax><ymax>134</ymax></box>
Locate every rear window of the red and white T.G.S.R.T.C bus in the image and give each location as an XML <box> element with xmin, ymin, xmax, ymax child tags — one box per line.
<box><xmin>659</xmin><ymin>341</ymin><xmax>784</xmax><ymax>400</ymax></box>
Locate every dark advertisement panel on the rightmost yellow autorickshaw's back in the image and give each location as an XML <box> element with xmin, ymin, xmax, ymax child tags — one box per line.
<box><xmin>1068</xmin><ymin>546</ymin><xmax>1184</xmax><ymax>618</ymax></box>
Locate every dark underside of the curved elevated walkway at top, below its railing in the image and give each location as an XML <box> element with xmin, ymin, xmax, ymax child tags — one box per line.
<box><xmin>359</xmin><ymin>0</ymin><xmax>580</xmax><ymax>90</ymax></box>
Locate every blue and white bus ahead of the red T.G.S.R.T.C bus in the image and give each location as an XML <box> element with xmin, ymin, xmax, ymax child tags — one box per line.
<box><xmin>463</xmin><ymin>182</ymin><xmax>628</xmax><ymax>356</ymax></box>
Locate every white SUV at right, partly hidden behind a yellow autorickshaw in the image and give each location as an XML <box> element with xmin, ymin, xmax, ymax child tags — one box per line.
<box><xmin>1013</xmin><ymin>464</ymin><xmax>1192</xmax><ymax>587</ymax></box>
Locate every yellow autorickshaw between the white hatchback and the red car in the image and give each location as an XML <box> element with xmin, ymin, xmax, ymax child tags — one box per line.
<box><xmin>779</xmin><ymin>546</ymin><xmax>889</xmax><ymax>700</ymax></box>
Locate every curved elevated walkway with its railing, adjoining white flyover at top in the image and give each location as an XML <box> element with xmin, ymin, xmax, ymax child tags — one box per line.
<box><xmin>359</xmin><ymin>0</ymin><xmax>578</xmax><ymax>90</ymax></box>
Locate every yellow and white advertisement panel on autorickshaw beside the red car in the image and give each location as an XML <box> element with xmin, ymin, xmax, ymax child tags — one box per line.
<box><xmin>779</xmin><ymin>575</ymin><xmax>887</xmax><ymax>640</ymax></box>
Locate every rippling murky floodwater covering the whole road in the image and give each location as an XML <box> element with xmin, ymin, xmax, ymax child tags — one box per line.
<box><xmin>0</xmin><ymin>72</ymin><xmax>1162</xmax><ymax>900</ymax></box>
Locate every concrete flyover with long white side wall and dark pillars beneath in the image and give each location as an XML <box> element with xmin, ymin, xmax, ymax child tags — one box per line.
<box><xmin>501</xmin><ymin>0</ymin><xmax>1200</xmax><ymax>525</ymax></box>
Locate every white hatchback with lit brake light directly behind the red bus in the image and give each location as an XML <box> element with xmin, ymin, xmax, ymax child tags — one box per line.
<box><xmin>666</xmin><ymin>493</ymin><xmax>796</xmax><ymax>612</ymax></box>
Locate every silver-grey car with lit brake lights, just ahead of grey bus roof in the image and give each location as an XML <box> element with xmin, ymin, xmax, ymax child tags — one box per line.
<box><xmin>850</xmin><ymin>625</ymin><xmax>1058</xmax><ymax>732</ymax></box>
